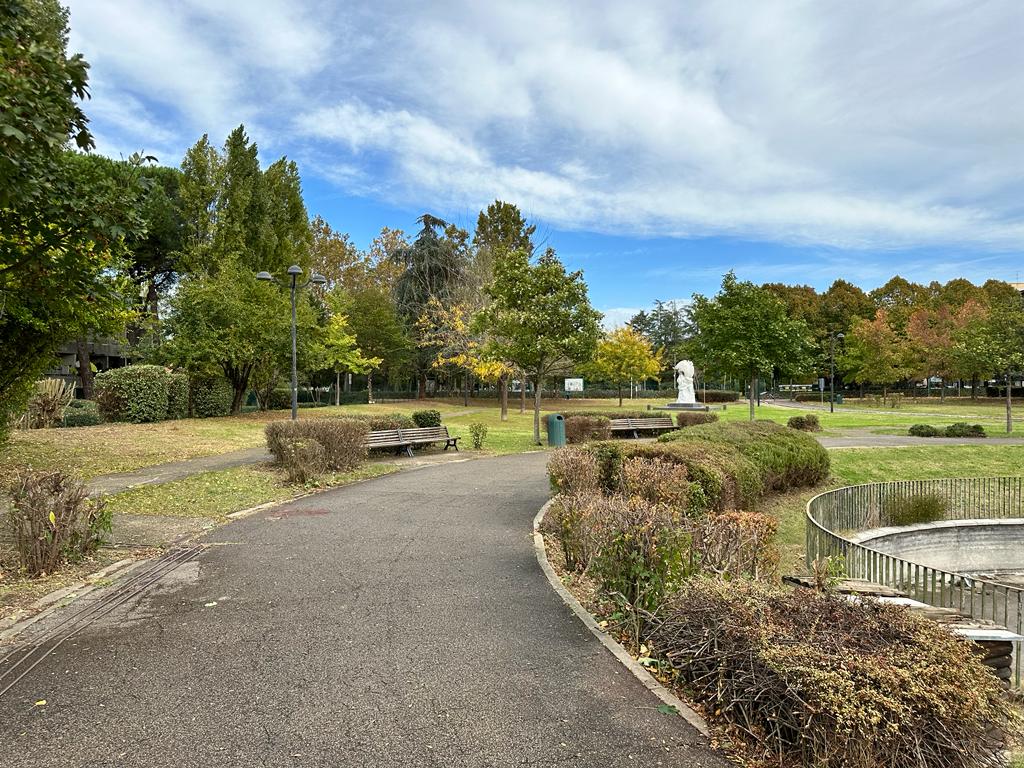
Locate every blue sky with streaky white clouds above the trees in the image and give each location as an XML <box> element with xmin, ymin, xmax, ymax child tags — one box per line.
<box><xmin>70</xmin><ymin>0</ymin><xmax>1024</xmax><ymax>325</ymax></box>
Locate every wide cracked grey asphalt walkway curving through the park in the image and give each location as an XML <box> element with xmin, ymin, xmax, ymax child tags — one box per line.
<box><xmin>0</xmin><ymin>454</ymin><xmax>728</xmax><ymax>768</ymax></box>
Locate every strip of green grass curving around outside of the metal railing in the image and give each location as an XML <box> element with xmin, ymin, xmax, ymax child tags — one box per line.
<box><xmin>765</xmin><ymin>445</ymin><xmax>1024</xmax><ymax>573</ymax></box>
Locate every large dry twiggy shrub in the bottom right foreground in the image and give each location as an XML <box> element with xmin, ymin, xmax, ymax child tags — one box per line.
<box><xmin>646</xmin><ymin>579</ymin><xmax>1012</xmax><ymax>768</ymax></box>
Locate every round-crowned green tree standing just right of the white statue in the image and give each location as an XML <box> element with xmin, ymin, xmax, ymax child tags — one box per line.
<box><xmin>690</xmin><ymin>272</ymin><xmax>810</xmax><ymax>421</ymax></box>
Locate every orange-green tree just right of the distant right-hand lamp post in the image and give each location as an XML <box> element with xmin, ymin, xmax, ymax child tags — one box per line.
<box><xmin>839</xmin><ymin>309</ymin><xmax>913</xmax><ymax>401</ymax></box>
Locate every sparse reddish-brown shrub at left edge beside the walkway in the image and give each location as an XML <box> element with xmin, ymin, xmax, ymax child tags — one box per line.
<box><xmin>4</xmin><ymin>469</ymin><xmax>111</xmax><ymax>575</ymax></box>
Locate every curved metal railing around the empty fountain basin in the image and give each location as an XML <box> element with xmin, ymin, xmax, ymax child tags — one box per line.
<box><xmin>806</xmin><ymin>477</ymin><xmax>1024</xmax><ymax>688</ymax></box>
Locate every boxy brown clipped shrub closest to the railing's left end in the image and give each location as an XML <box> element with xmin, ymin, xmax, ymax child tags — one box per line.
<box><xmin>692</xmin><ymin>512</ymin><xmax>778</xmax><ymax>579</ymax></box>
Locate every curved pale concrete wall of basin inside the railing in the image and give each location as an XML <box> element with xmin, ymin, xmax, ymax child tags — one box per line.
<box><xmin>848</xmin><ymin>518</ymin><xmax>1024</xmax><ymax>573</ymax></box>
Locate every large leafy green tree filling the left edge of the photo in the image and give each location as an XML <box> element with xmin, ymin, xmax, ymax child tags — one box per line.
<box><xmin>0</xmin><ymin>0</ymin><xmax>143</xmax><ymax>437</ymax></box>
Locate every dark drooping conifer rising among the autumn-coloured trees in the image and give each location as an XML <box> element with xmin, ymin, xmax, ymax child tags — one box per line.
<box><xmin>391</xmin><ymin>213</ymin><xmax>468</xmax><ymax>398</ymax></box>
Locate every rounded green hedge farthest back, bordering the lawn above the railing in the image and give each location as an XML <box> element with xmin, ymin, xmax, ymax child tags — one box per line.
<box><xmin>658</xmin><ymin>421</ymin><xmax>830</xmax><ymax>490</ymax></box>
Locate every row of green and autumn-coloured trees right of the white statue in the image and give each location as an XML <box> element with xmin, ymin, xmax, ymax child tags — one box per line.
<box><xmin>655</xmin><ymin>272</ymin><xmax>1024</xmax><ymax>428</ymax></box>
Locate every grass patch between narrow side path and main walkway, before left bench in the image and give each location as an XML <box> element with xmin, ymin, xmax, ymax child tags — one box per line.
<box><xmin>108</xmin><ymin>463</ymin><xmax>398</xmax><ymax>520</ymax></box>
